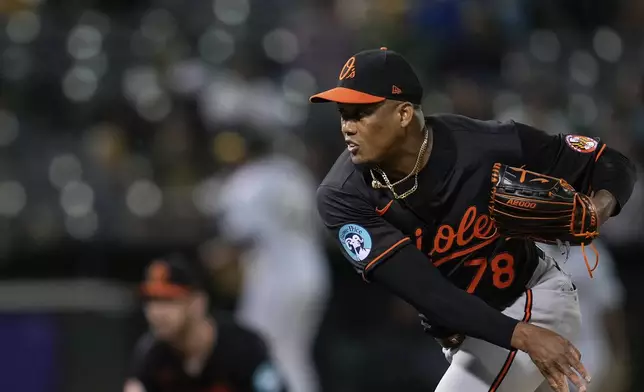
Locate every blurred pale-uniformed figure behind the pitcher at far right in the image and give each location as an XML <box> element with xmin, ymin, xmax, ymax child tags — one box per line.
<box><xmin>539</xmin><ymin>240</ymin><xmax>627</xmax><ymax>392</ymax></box>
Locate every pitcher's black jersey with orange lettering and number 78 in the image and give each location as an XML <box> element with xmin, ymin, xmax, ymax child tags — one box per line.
<box><xmin>318</xmin><ymin>115</ymin><xmax>632</xmax><ymax>309</ymax></box>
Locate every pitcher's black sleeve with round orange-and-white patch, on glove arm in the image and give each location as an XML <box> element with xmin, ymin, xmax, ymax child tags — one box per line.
<box><xmin>515</xmin><ymin>123</ymin><xmax>635</xmax><ymax>215</ymax></box>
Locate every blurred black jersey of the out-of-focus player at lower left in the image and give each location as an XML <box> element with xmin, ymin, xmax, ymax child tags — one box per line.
<box><xmin>130</xmin><ymin>320</ymin><xmax>284</xmax><ymax>392</ymax></box>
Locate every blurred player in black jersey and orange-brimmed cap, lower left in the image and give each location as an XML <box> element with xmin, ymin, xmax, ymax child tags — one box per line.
<box><xmin>124</xmin><ymin>255</ymin><xmax>284</xmax><ymax>392</ymax></box>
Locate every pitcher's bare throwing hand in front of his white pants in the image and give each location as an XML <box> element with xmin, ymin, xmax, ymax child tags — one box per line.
<box><xmin>512</xmin><ymin>323</ymin><xmax>590</xmax><ymax>392</ymax></box>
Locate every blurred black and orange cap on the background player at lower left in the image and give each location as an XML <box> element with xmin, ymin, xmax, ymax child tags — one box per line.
<box><xmin>141</xmin><ymin>254</ymin><xmax>204</xmax><ymax>299</ymax></box>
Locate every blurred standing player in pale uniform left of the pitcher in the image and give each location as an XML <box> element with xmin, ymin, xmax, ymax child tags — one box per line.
<box><xmin>206</xmin><ymin>133</ymin><xmax>330</xmax><ymax>392</ymax></box>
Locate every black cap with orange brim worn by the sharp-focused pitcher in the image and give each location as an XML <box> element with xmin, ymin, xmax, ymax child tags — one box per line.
<box><xmin>309</xmin><ymin>47</ymin><xmax>423</xmax><ymax>105</ymax></box>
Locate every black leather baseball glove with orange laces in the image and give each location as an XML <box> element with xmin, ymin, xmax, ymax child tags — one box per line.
<box><xmin>489</xmin><ymin>163</ymin><xmax>599</xmax><ymax>245</ymax></box>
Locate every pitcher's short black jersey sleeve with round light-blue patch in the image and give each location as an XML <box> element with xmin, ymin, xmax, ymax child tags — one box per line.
<box><xmin>317</xmin><ymin>185</ymin><xmax>410</xmax><ymax>279</ymax></box>
